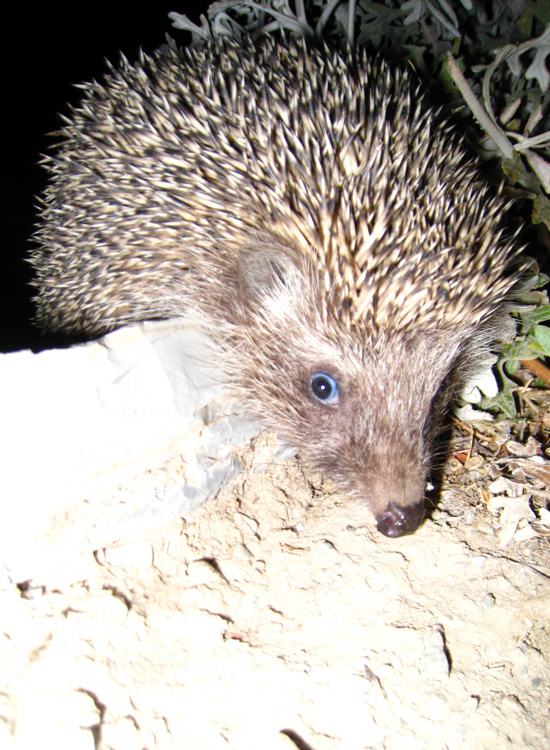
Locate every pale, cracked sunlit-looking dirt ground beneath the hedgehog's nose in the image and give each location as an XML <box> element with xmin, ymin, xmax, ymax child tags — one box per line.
<box><xmin>0</xmin><ymin>438</ymin><xmax>550</xmax><ymax>750</ymax></box>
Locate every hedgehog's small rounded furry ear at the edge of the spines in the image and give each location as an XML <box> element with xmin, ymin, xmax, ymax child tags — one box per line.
<box><xmin>239</xmin><ymin>239</ymin><xmax>297</xmax><ymax>302</ymax></box>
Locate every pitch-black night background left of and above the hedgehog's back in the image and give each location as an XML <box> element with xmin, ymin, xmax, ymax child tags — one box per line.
<box><xmin>0</xmin><ymin>0</ymin><xmax>209</xmax><ymax>352</ymax></box>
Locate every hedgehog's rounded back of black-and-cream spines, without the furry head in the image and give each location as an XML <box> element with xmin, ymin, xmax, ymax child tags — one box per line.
<box><xmin>32</xmin><ymin>40</ymin><xmax>512</xmax><ymax>334</ymax></box>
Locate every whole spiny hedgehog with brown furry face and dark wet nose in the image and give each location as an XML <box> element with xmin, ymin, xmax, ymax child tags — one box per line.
<box><xmin>31</xmin><ymin>39</ymin><xmax>519</xmax><ymax>537</ymax></box>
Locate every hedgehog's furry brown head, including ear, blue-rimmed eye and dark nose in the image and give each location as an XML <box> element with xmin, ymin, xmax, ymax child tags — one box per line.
<box><xmin>234</xmin><ymin>239</ymin><xmax>470</xmax><ymax>537</ymax></box>
